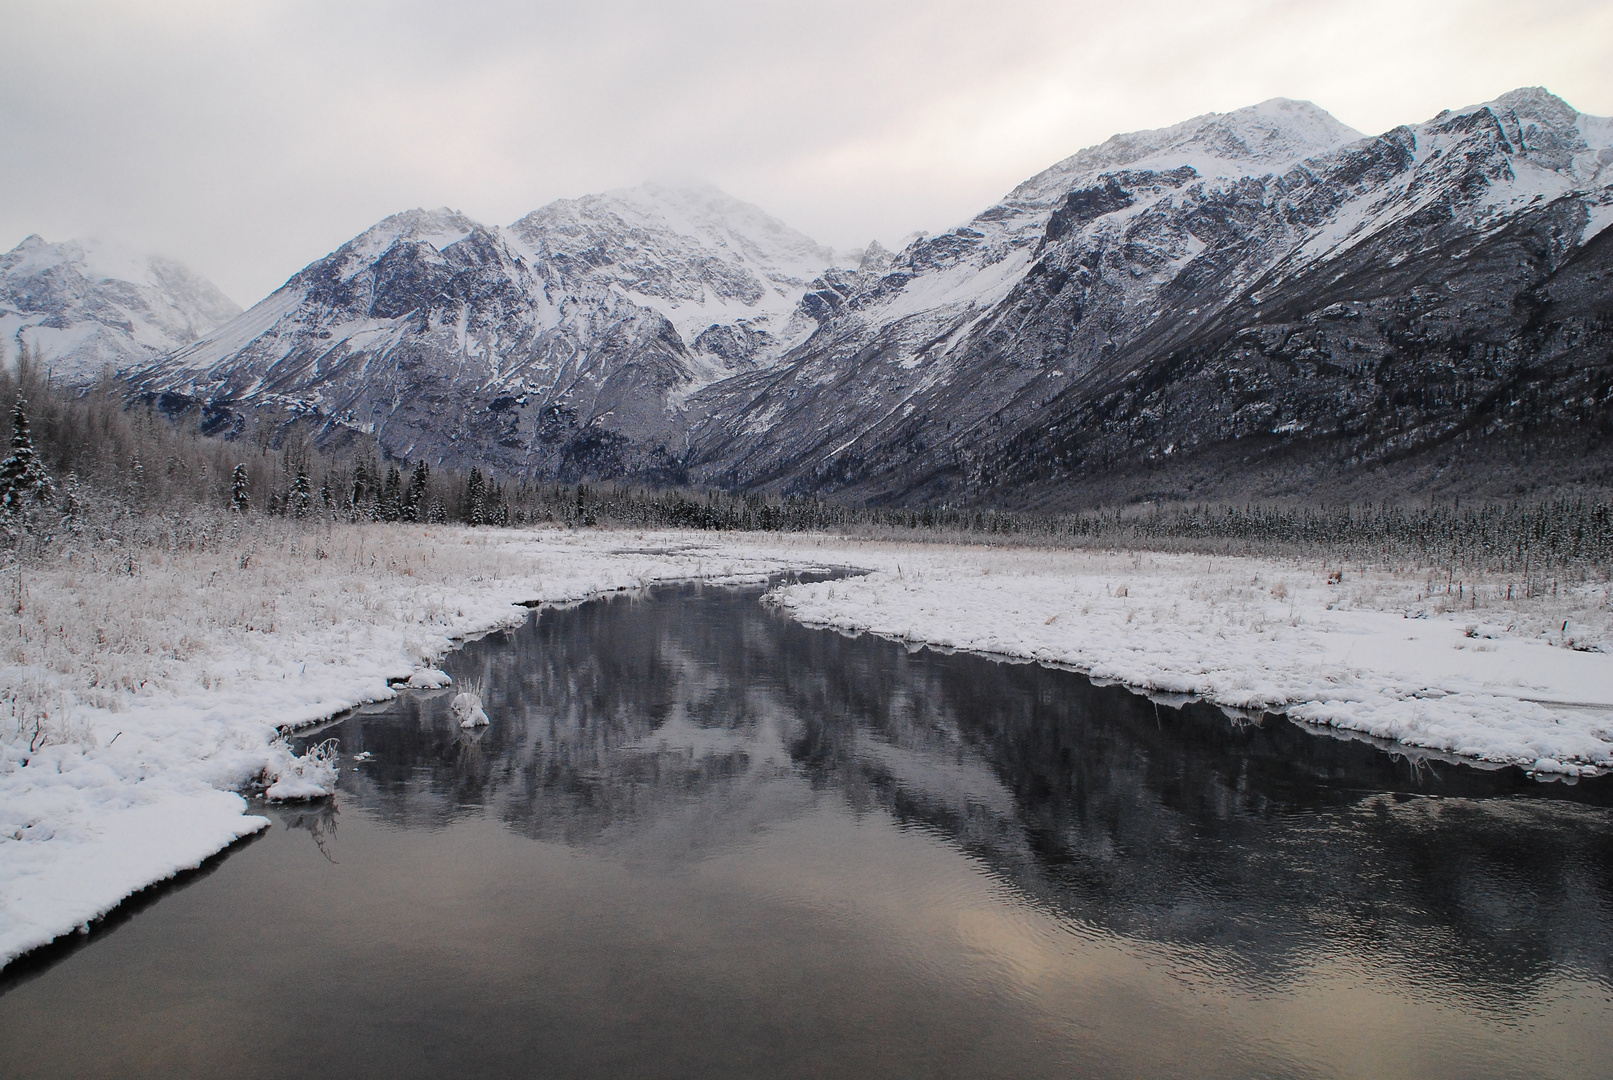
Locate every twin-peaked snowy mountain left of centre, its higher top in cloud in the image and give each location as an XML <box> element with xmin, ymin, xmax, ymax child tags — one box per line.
<box><xmin>132</xmin><ymin>185</ymin><xmax>831</xmax><ymax>482</ymax></box>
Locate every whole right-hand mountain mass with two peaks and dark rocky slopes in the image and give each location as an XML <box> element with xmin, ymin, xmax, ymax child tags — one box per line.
<box><xmin>694</xmin><ymin>90</ymin><xmax>1613</xmax><ymax>505</ymax></box>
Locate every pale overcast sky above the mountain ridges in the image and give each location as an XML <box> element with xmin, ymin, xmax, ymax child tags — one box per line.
<box><xmin>0</xmin><ymin>0</ymin><xmax>1613</xmax><ymax>305</ymax></box>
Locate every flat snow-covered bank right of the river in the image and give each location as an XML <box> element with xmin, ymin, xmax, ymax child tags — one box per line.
<box><xmin>768</xmin><ymin>550</ymin><xmax>1613</xmax><ymax>775</ymax></box>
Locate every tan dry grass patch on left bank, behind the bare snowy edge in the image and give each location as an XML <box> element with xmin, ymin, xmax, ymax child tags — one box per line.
<box><xmin>0</xmin><ymin>516</ymin><xmax>529</xmax><ymax>746</ymax></box>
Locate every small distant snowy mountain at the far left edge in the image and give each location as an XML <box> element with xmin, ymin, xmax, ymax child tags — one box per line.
<box><xmin>0</xmin><ymin>235</ymin><xmax>240</xmax><ymax>385</ymax></box>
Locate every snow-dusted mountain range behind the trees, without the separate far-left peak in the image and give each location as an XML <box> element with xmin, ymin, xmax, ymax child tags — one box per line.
<box><xmin>22</xmin><ymin>89</ymin><xmax>1613</xmax><ymax>506</ymax></box>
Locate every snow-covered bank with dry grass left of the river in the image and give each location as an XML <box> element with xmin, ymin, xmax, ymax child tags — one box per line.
<box><xmin>0</xmin><ymin>525</ymin><xmax>811</xmax><ymax>962</ymax></box>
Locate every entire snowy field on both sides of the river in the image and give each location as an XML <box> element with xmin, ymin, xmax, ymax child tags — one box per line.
<box><xmin>0</xmin><ymin>524</ymin><xmax>1613</xmax><ymax>962</ymax></box>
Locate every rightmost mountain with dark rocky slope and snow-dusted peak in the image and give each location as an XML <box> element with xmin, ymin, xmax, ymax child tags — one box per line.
<box><xmin>973</xmin><ymin>90</ymin><xmax>1613</xmax><ymax>506</ymax></box>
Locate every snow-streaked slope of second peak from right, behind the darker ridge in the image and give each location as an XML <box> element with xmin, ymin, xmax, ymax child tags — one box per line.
<box><xmin>695</xmin><ymin>98</ymin><xmax>1360</xmax><ymax>487</ymax></box>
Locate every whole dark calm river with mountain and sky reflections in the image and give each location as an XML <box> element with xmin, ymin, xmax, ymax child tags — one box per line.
<box><xmin>0</xmin><ymin>588</ymin><xmax>1613</xmax><ymax>1078</ymax></box>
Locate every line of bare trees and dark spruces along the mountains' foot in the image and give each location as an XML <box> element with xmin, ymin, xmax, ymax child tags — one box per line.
<box><xmin>0</xmin><ymin>344</ymin><xmax>1613</xmax><ymax>579</ymax></box>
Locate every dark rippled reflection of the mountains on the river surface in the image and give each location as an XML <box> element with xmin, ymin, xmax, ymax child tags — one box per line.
<box><xmin>346</xmin><ymin>588</ymin><xmax>1613</xmax><ymax>1007</ymax></box>
